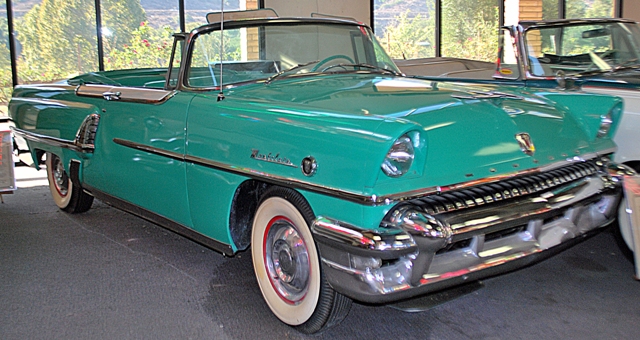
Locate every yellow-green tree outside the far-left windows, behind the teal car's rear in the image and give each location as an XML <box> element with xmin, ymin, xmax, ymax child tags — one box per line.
<box><xmin>16</xmin><ymin>0</ymin><xmax>145</xmax><ymax>81</ymax></box>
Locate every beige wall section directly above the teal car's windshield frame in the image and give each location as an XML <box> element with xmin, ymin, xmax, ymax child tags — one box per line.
<box><xmin>264</xmin><ymin>0</ymin><xmax>371</xmax><ymax>25</ymax></box>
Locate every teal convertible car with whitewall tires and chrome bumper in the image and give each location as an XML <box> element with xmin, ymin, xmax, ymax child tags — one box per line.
<box><xmin>9</xmin><ymin>12</ymin><xmax>626</xmax><ymax>333</ymax></box>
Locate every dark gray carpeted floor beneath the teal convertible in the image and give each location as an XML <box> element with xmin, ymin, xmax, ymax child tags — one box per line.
<box><xmin>0</xmin><ymin>168</ymin><xmax>640</xmax><ymax>339</ymax></box>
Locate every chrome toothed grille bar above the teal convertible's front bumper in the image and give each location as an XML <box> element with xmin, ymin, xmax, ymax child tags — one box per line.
<box><xmin>403</xmin><ymin>160</ymin><xmax>602</xmax><ymax>215</ymax></box>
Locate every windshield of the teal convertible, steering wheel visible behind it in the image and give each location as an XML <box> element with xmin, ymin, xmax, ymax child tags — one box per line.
<box><xmin>186</xmin><ymin>23</ymin><xmax>398</xmax><ymax>88</ymax></box>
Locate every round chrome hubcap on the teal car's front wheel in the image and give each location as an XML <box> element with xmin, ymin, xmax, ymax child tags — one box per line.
<box><xmin>265</xmin><ymin>218</ymin><xmax>310</xmax><ymax>304</ymax></box>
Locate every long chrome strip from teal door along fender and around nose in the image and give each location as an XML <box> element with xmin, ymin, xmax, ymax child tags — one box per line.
<box><xmin>113</xmin><ymin>138</ymin><xmax>612</xmax><ymax>206</ymax></box>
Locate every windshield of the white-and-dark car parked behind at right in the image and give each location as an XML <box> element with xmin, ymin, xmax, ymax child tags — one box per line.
<box><xmin>525</xmin><ymin>22</ymin><xmax>640</xmax><ymax>76</ymax></box>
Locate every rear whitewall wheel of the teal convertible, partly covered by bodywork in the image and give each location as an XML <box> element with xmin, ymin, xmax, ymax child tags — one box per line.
<box><xmin>46</xmin><ymin>153</ymin><xmax>93</xmax><ymax>214</ymax></box>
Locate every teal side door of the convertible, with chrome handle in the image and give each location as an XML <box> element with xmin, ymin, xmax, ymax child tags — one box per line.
<box><xmin>76</xmin><ymin>85</ymin><xmax>198</xmax><ymax>226</ymax></box>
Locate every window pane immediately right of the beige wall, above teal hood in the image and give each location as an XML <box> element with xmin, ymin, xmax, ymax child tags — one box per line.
<box><xmin>373</xmin><ymin>0</ymin><xmax>438</xmax><ymax>59</ymax></box>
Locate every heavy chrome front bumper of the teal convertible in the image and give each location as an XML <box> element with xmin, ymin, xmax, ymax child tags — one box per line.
<box><xmin>312</xmin><ymin>163</ymin><xmax>626</xmax><ymax>303</ymax></box>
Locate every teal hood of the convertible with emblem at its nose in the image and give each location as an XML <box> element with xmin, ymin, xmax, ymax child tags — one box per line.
<box><xmin>229</xmin><ymin>75</ymin><xmax>602</xmax><ymax>186</ymax></box>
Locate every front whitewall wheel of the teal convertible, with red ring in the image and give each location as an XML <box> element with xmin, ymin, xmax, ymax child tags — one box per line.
<box><xmin>251</xmin><ymin>188</ymin><xmax>351</xmax><ymax>334</ymax></box>
